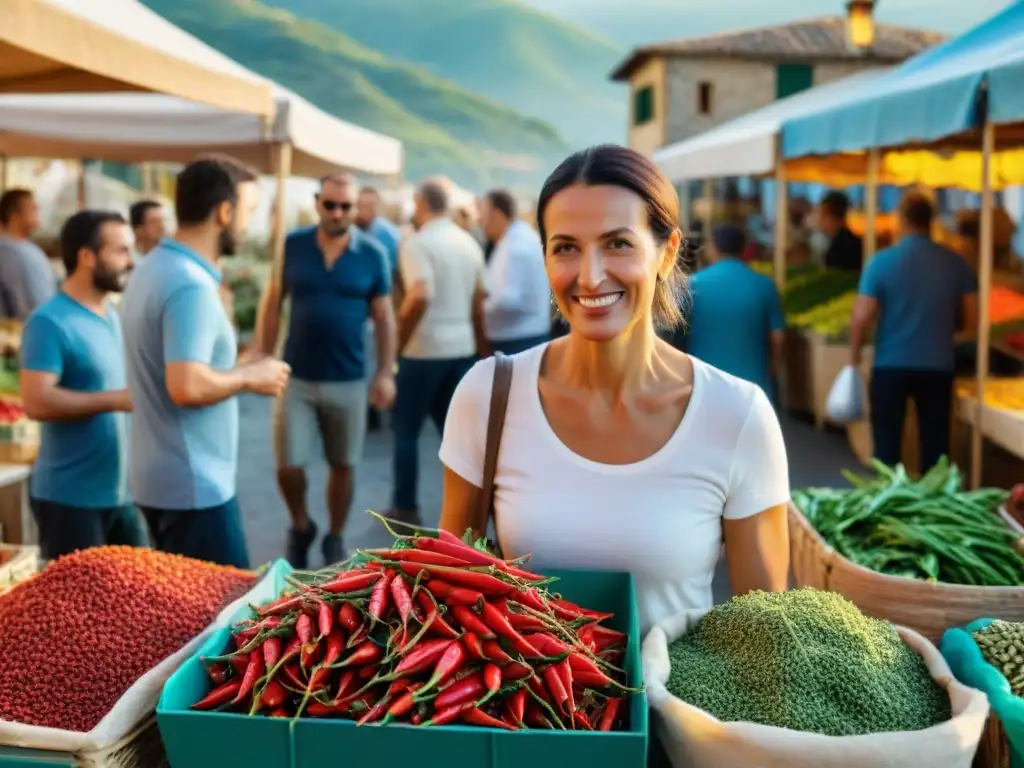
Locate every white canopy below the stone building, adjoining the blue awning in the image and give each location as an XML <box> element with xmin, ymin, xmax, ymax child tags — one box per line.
<box><xmin>654</xmin><ymin>70</ymin><xmax>888</xmax><ymax>183</ymax></box>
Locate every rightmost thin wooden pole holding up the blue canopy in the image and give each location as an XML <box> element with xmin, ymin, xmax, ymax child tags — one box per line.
<box><xmin>971</xmin><ymin>119</ymin><xmax>995</xmax><ymax>488</ymax></box>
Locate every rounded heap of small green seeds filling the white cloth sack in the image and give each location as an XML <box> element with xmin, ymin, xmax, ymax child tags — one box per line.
<box><xmin>668</xmin><ymin>589</ymin><xmax>950</xmax><ymax>736</ymax></box>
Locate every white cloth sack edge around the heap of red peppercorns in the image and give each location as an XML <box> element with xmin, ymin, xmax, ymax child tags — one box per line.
<box><xmin>0</xmin><ymin>560</ymin><xmax>287</xmax><ymax>753</ymax></box>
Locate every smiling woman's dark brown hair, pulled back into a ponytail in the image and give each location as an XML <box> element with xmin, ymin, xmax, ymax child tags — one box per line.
<box><xmin>537</xmin><ymin>144</ymin><xmax>686</xmax><ymax>329</ymax></box>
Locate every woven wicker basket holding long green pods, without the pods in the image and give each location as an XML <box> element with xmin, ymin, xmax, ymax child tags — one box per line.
<box><xmin>790</xmin><ymin>504</ymin><xmax>1024</xmax><ymax>643</ymax></box>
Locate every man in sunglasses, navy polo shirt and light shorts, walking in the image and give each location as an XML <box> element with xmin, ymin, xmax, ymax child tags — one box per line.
<box><xmin>255</xmin><ymin>174</ymin><xmax>396</xmax><ymax>568</ymax></box>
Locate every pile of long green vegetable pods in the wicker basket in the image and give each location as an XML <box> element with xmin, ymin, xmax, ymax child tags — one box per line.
<box><xmin>793</xmin><ymin>459</ymin><xmax>1024</xmax><ymax>587</ymax></box>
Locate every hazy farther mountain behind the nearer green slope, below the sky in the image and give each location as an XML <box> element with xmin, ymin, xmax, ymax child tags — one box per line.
<box><xmin>265</xmin><ymin>0</ymin><xmax>627</xmax><ymax>146</ymax></box>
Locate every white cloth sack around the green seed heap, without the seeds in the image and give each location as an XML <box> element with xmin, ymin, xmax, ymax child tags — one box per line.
<box><xmin>641</xmin><ymin>610</ymin><xmax>988</xmax><ymax>768</ymax></box>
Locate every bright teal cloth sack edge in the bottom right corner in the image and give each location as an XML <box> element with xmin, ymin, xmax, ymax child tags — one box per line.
<box><xmin>942</xmin><ymin>618</ymin><xmax>1024</xmax><ymax>768</ymax></box>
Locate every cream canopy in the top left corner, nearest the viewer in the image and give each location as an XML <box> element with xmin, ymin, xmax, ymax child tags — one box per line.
<box><xmin>0</xmin><ymin>0</ymin><xmax>273</xmax><ymax>116</ymax></box>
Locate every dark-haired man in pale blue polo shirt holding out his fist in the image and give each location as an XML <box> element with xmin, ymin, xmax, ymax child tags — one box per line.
<box><xmin>121</xmin><ymin>158</ymin><xmax>289</xmax><ymax>567</ymax></box>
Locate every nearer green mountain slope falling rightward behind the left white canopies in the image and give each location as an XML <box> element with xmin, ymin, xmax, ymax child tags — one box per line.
<box><xmin>144</xmin><ymin>0</ymin><xmax>568</xmax><ymax>187</ymax></box>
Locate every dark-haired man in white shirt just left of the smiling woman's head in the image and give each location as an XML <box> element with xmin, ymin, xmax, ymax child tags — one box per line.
<box><xmin>480</xmin><ymin>189</ymin><xmax>551</xmax><ymax>354</ymax></box>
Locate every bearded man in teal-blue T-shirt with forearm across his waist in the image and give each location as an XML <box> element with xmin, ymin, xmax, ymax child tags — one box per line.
<box><xmin>20</xmin><ymin>211</ymin><xmax>145</xmax><ymax>560</ymax></box>
